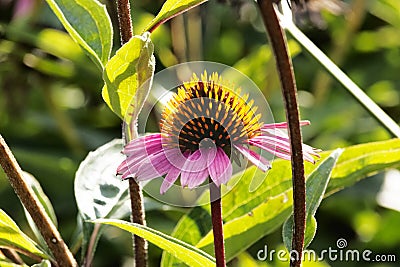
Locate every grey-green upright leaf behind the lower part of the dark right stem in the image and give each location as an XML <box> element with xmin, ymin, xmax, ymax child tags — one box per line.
<box><xmin>282</xmin><ymin>149</ymin><xmax>342</xmax><ymax>251</ymax></box>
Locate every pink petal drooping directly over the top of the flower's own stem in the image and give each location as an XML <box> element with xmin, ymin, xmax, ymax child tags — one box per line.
<box><xmin>207</xmin><ymin>147</ymin><xmax>232</xmax><ymax>186</ymax></box>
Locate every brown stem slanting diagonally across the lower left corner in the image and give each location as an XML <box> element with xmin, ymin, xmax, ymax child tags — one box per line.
<box><xmin>0</xmin><ymin>135</ymin><xmax>77</xmax><ymax>267</ymax></box>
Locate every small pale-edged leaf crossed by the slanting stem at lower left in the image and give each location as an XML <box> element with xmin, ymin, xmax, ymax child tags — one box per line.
<box><xmin>24</xmin><ymin>172</ymin><xmax>57</xmax><ymax>254</ymax></box>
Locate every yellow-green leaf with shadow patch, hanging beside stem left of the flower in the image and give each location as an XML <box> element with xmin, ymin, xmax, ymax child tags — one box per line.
<box><xmin>102</xmin><ymin>33</ymin><xmax>155</xmax><ymax>124</ymax></box>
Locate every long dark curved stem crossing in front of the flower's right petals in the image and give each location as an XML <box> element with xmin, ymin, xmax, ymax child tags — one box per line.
<box><xmin>258</xmin><ymin>0</ymin><xmax>306</xmax><ymax>267</ymax></box>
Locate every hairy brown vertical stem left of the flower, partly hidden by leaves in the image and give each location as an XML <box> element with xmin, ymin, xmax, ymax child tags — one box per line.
<box><xmin>117</xmin><ymin>0</ymin><xmax>147</xmax><ymax>267</ymax></box>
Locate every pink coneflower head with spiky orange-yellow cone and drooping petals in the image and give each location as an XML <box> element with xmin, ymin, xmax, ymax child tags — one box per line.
<box><xmin>117</xmin><ymin>73</ymin><xmax>319</xmax><ymax>194</ymax></box>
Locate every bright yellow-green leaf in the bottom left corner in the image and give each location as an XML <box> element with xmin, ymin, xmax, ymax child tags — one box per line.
<box><xmin>0</xmin><ymin>209</ymin><xmax>49</xmax><ymax>259</ymax></box>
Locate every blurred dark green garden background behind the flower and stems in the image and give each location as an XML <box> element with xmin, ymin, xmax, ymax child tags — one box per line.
<box><xmin>0</xmin><ymin>0</ymin><xmax>400</xmax><ymax>266</ymax></box>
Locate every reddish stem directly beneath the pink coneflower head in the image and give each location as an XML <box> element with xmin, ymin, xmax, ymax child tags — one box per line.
<box><xmin>210</xmin><ymin>178</ymin><xmax>226</xmax><ymax>267</ymax></box>
